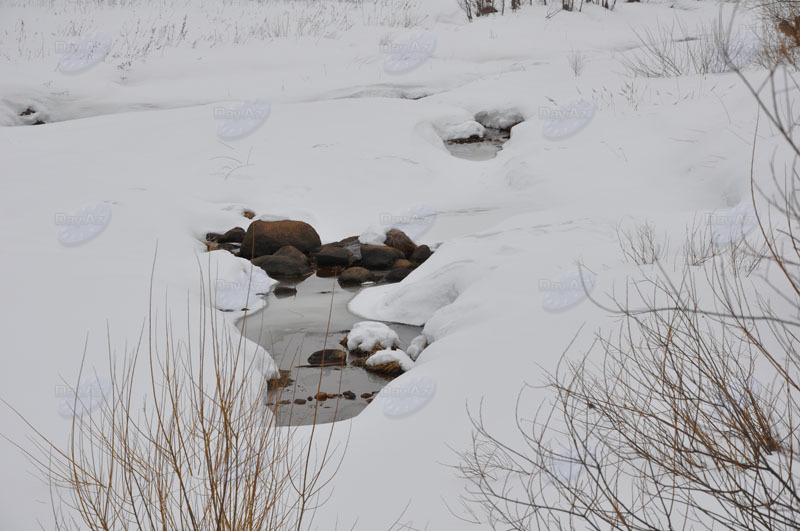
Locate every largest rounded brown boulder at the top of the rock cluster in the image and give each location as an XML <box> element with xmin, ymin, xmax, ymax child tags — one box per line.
<box><xmin>240</xmin><ymin>220</ymin><xmax>322</xmax><ymax>258</ymax></box>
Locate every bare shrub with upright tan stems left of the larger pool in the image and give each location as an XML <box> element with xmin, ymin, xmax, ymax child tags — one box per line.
<box><xmin>5</xmin><ymin>268</ymin><xmax>344</xmax><ymax>531</ymax></box>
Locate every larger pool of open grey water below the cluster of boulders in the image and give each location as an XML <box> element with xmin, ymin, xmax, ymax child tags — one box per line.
<box><xmin>238</xmin><ymin>275</ymin><xmax>422</xmax><ymax>426</ymax></box>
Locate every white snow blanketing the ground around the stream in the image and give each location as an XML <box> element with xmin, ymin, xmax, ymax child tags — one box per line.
<box><xmin>0</xmin><ymin>0</ymin><xmax>778</xmax><ymax>531</ymax></box>
